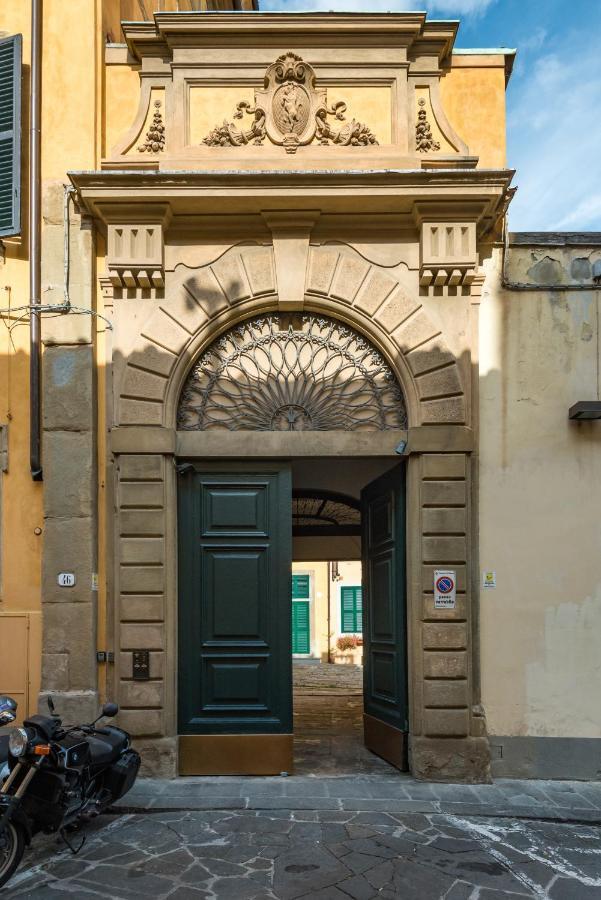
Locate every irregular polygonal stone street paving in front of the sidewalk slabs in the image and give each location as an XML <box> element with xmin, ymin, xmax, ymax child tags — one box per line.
<box><xmin>3</xmin><ymin>809</ymin><xmax>601</xmax><ymax>900</ymax></box>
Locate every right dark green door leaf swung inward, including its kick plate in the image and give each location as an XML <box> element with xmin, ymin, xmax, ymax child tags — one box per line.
<box><xmin>361</xmin><ymin>465</ymin><xmax>408</xmax><ymax>768</ymax></box>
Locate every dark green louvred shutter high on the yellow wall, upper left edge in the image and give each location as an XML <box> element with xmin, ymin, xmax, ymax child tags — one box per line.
<box><xmin>0</xmin><ymin>34</ymin><xmax>22</xmax><ymax>237</ymax></box>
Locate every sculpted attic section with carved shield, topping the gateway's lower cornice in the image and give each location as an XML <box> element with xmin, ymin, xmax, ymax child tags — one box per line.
<box><xmin>103</xmin><ymin>13</ymin><xmax>510</xmax><ymax>171</ymax></box>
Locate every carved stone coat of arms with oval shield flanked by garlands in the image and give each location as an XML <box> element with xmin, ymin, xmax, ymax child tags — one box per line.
<box><xmin>203</xmin><ymin>53</ymin><xmax>378</xmax><ymax>153</ymax></box>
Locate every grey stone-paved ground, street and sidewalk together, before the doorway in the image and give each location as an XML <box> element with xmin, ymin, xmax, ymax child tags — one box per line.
<box><xmin>2</xmin><ymin>773</ymin><xmax>601</xmax><ymax>900</ymax></box>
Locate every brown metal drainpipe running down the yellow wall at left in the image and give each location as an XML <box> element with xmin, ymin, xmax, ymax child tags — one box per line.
<box><xmin>29</xmin><ymin>0</ymin><xmax>43</xmax><ymax>481</ymax></box>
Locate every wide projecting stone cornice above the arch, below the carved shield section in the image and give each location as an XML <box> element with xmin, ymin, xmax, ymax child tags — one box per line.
<box><xmin>69</xmin><ymin>169</ymin><xmax>514</xmax><ymax>230</ymax></box>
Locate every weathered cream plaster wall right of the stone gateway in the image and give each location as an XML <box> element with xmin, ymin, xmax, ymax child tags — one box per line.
<box><xmin>480</xmin><ymin>247</ymin><xmax>601</xmax><ymax>737</ymax></box>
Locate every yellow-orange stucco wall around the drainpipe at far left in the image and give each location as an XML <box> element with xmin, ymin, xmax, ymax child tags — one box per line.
<box><xmin>0</xmin><ymin>0</ymin><xmax>101</xmax><ymax>717</ymax></box>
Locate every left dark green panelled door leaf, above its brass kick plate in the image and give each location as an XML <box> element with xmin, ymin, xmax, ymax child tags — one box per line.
<box><xmin>178</xmin><ymin>463</ymin><xmax>292</xmax><ymax>735</ymax></box>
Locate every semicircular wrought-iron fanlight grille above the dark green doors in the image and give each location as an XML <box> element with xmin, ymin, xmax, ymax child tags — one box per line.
<box><xmin>178</xmin><ymin>314</ymin><xmax>407</xmax><ymax>431</ymax></box>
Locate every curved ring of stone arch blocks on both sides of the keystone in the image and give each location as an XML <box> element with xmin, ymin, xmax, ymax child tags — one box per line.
<box><xmin>116</xmin><ymin>245</ymin><xmax>466</xmax><ymax>428</ymax></box>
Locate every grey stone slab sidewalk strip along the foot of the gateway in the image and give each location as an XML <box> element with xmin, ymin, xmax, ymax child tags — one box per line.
<box><xmin>116</xmin><ymin>774</ymin><xmax>601</xmax><ymax>823</ymax></box>
